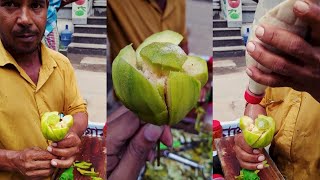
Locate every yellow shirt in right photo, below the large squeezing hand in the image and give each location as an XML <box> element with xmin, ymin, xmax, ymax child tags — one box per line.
<box><xmin>261</xmin><ymin>88</ymin><xmax>320</xmax><ymax>180</ymax></box>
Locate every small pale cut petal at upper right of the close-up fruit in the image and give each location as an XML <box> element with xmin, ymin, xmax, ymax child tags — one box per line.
<box><xmin>182</xmin><ymin>56</ymin><xmax>208</xmax><ymax>87</ymax></box>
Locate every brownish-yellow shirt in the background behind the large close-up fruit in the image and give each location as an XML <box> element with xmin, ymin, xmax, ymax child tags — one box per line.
<box><xmin>107</xmin><ymin>0</ymin><xmax>187</xmax><ymax>61</ymax></box>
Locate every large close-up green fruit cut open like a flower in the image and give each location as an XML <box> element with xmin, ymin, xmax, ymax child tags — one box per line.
<box><xmin>112</xmin><ymin>31</ymin><xmax>208</xmax><ymax>125</ymax></box>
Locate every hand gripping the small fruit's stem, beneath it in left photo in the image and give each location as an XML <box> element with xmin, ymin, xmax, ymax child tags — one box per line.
<box><xmin>47</xmin><ymin>131</ymin><xmax>81</xmax><ymax>168</ymax></box>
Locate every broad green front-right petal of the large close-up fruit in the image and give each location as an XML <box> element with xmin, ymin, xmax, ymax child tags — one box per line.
<box><xmin>166</xmin><ymin>72</ymin><xmax>201</xmax><ymax>125</ymax></box>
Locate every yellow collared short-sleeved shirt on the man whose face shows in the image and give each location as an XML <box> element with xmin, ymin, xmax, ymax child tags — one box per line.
<box><xmin>0</xmin><ymin>41</ymin><xmax>86</xmax><ymax>180</ymax></box>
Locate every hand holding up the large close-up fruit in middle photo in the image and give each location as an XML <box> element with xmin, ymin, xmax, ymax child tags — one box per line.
<box><xmin>107</xmin><ymin>107</ymin><xmax>172</xmax><ymax>180</ymax></box>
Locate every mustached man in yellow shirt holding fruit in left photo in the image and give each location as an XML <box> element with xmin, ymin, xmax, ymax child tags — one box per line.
<box><xmin>0</xmin><ymin>0</ymin><xmax>88</xmax><ymax>179</ymax></box>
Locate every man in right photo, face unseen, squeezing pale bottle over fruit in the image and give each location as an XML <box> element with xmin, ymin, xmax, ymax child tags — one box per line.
<box><xmin>234</xmin><ymin>0</ymin><xmax>320</xmax><ymax>180</ymax></box>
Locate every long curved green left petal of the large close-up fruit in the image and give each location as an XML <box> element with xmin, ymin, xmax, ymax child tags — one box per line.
<box><xmin>112</xmin><ymin>45</ymin><xmax>168</xmax><ymax>123</ymax></box>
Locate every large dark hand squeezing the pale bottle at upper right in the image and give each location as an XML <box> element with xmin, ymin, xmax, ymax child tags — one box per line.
<box><xmin>247</xmin><ymin>1</ymin><xmax>320</xmax><ymax>102</ymax></box>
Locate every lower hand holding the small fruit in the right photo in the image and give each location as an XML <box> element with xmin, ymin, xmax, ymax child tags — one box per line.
<box><xmin>233</xmin><ymin>133</ymin><xmax>266</xmax><ymax>170</ymax></box>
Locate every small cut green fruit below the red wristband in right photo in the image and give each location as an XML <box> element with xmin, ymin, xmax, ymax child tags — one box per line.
<box><xmin>240</xmin><ymin>115</ymin><xmax>276</xmax><ymax>148</ymax></box>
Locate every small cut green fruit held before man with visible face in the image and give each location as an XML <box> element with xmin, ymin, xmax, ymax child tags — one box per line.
<box><xmin>41</xmin><ymin>111</ymin><xmax>73</xmax><ymax>142</ymax></box>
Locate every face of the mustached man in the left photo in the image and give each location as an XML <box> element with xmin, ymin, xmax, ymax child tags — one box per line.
<box><xmin>0</xmin><ymin>0</ymin><xmax>48</xmax><ymax>54</ymax></box>
